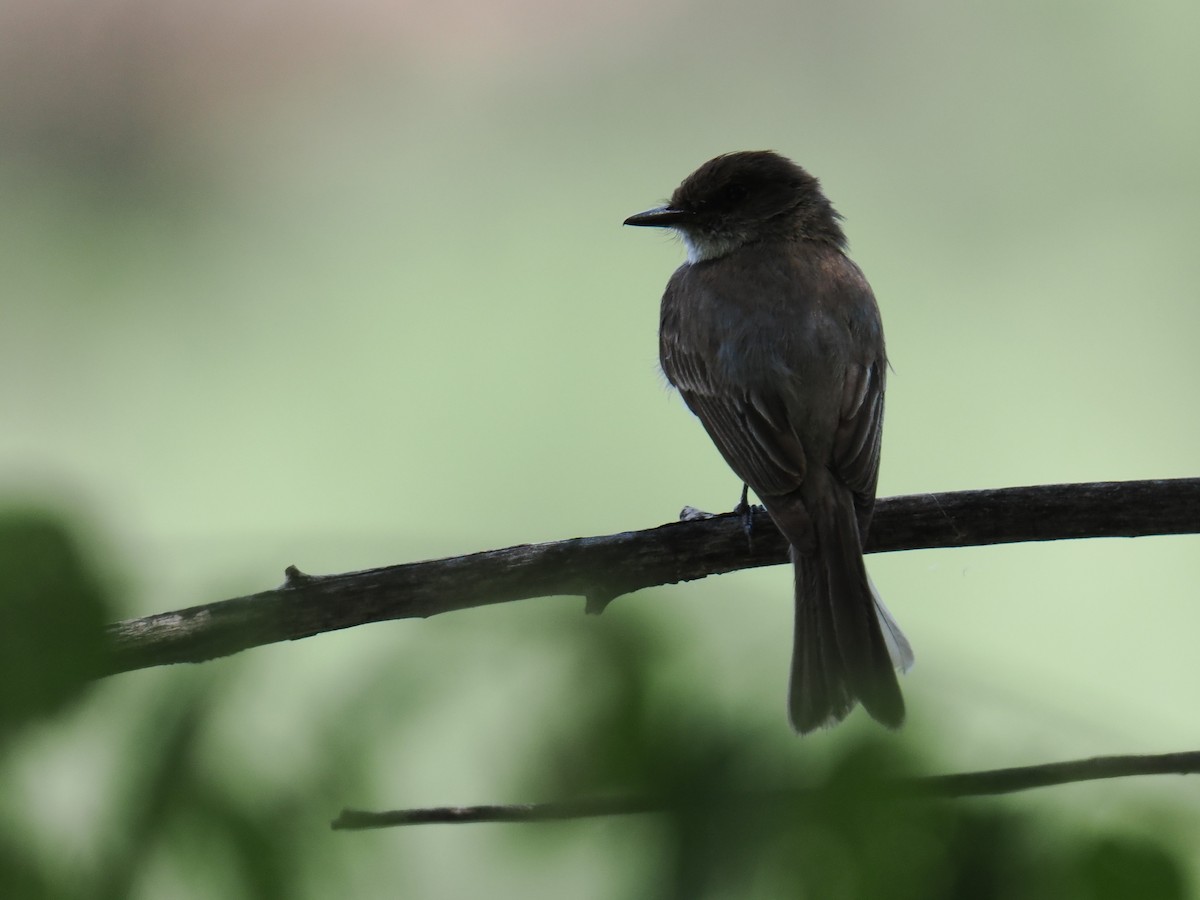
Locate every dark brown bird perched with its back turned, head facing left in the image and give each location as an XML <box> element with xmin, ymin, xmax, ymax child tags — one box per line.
<box><xmin>625</xmin><ymin>151</ymin><xmax>912</xmax><ymax>734</ymax></box>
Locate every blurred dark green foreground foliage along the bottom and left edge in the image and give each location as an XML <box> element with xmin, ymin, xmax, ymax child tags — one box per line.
<box><xmin>0</xmin><ymin>512</ymin><xmax>1187</xmax><ymax>900</ymax></box>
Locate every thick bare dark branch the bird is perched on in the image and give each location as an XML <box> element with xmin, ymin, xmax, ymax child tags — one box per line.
<box><xmin>102</xmin><ymin>478</ymin><xmax>1200</xmax><ymax>674</ymax></box>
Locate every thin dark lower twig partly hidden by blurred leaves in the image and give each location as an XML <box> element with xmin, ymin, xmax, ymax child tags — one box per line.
<box><xmin>330</xmin><ymin>751</ymin><xmax>1200</xmax><ymax>830</ymax></box>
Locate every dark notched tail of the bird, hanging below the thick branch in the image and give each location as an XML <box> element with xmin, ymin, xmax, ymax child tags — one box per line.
<box><xmin>788</xmin><ymin>498</ymin><xmax>913</xmax><ymax>734</ymax></box>
